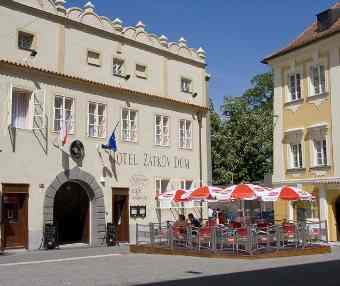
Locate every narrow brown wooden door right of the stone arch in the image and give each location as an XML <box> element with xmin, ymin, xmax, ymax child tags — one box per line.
<box><xmin>112</xmin><ymin>188</ymin><xmax>129</xmax><ymax>242</ymax></box>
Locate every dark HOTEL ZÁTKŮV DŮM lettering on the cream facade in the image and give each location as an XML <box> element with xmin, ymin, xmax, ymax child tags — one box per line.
<box><xmin>115</xmin><ymin>152</ymin><xmax>190</xmax><ymax>169</ymax></box>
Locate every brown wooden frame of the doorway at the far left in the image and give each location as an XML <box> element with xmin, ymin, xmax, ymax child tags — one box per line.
<box><xmin>0</xmin><ymin>183</ymin><xmax>30</xmax><ymax>249</ymax></box>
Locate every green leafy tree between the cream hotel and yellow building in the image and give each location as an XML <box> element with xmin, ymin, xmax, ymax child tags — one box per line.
<box><xmin>210</xmin><ymin>70</ymin><xmax>273</xmax><ymax>185</ymax></box>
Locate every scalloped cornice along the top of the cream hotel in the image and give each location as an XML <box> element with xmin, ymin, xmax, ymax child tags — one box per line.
<box><xmin>1</xmin><ymin>0</ymin><xmax>206</xmax><ymax>68</ymax></box>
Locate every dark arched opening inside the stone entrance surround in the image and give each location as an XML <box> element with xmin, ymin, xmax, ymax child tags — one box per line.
<box><xmin>53</xmin><ymin>182</ymin><xmax>90</xmax><ymax>244</ymax></box>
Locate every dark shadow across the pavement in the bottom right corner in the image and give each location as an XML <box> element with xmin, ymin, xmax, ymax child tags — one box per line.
<box><xmin>139</xmin><ymin>257</ymin><xmax>340</xmax><ymax>286</ymax></box>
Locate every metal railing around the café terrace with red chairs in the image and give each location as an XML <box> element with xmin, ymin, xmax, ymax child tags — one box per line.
<box><xmin>136</xmin><ymin>221</ymin><xmax>328</xmax><ymax>255</ymax></box>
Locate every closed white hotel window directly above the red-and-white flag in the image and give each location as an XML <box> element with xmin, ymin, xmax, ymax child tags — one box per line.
<box><xmin>54</xmin><ymin>95</ymin><xmax>74</xmax><ymax>134</ymax></box>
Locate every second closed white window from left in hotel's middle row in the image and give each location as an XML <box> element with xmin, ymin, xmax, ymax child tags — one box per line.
<box><xmin>88</xmin><ymin>102</ymin><xmax>106</xmax><ymax>138</ymax></box>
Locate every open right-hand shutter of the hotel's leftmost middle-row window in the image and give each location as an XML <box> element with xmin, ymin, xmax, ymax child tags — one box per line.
<box><xmin>32</xmin><ymin>89</ymin><xmax>46</xmax><ymax>130</ymax></box>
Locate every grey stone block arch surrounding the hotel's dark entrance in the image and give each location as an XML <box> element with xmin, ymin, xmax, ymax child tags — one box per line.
<box><xmin>43</xmin><ymin>167</ymin><xmax>105</xmax><ymax>246</ymax></box>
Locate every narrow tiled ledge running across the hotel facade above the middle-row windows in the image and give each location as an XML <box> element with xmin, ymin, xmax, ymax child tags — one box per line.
<box><xmin>0</xmin><ymin>59</ymin><xmax>209</xmax><ymax>113</ymax></box>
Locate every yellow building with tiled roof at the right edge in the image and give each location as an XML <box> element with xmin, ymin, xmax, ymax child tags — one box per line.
<box><xmin>263</xmin><ymin>3</ymin><xmax>340</xmax><ymax>241</ymax></box>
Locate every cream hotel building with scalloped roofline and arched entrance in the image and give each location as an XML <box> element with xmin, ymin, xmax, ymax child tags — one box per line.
<box><xmin>0</xmin><ymin>0</ymin><xmax>211</xmax><ymax>249</ymax></box>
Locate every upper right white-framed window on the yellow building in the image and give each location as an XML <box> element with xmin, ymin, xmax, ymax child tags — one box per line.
<box><xmin>308</xmin><ymin>60</ymin><xmax>327</xmax><ymax>96</ymax></box>
